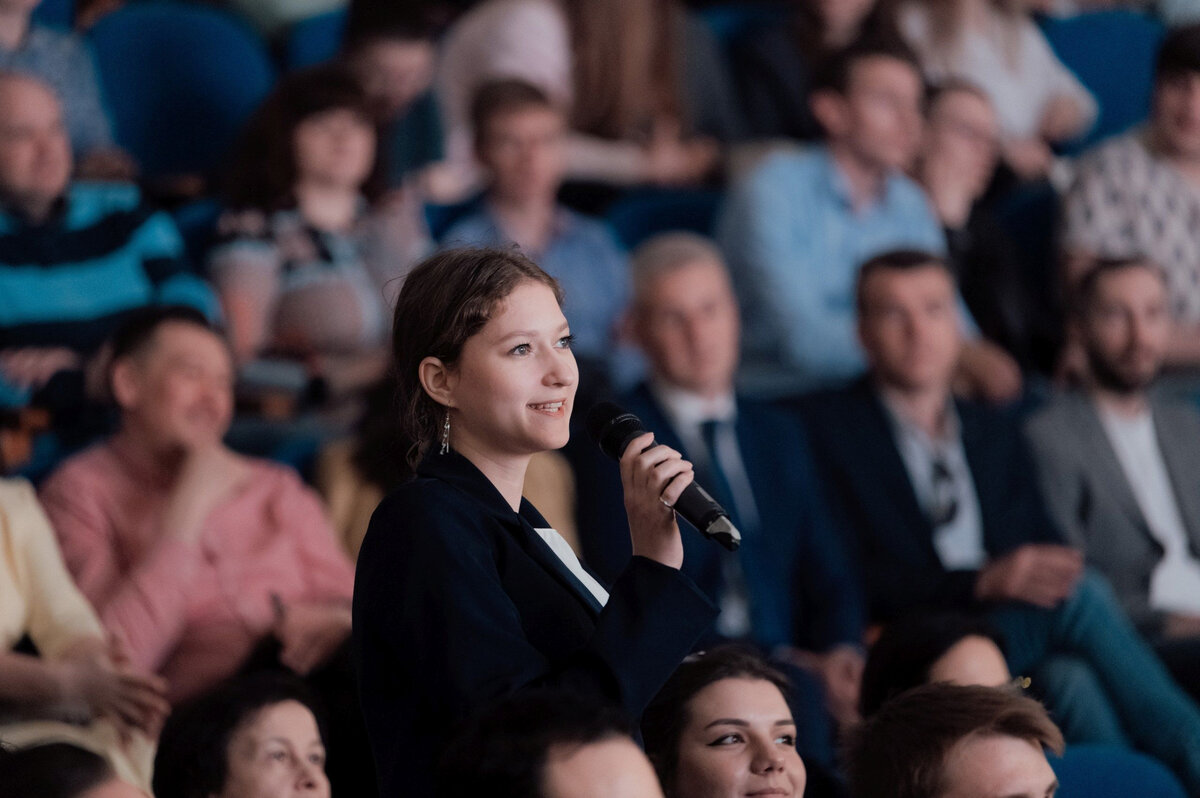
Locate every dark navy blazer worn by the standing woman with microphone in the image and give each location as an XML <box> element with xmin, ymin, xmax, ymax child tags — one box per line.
<box><xmin>353</xmin><ymin>452</ymin><xmax>716</xmax><ymax>798</ymax></box>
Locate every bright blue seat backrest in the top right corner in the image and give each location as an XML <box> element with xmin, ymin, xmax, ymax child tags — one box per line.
<box><xmin>1042</xmin><ymin>11</ymin><xmax>1164</xmax><ymax>154</ymax></box>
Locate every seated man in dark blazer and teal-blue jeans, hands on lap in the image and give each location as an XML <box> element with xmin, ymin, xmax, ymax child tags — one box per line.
<box><xmin>802</xmin><ymin>252</ymin><xmax>1200</xmax><ymax>792</ymax></box>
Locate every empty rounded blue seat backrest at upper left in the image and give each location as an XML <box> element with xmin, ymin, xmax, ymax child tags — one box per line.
<box><xmin>88</xmin><ymin>2</ymin><xmax>275</xmax><ymax>178</ymax></box>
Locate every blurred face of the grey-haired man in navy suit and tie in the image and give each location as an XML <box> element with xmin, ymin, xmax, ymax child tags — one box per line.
<box><xmin>634</xmin><ymin>260</ymin><xmax>740</xmax><ymax>396</ymax></box>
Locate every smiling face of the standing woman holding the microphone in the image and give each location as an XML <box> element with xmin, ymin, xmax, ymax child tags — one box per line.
<box><xmin>434</xmin><ymin>281</ymin><xmax>578</xmax><ymax>460</ymax></box>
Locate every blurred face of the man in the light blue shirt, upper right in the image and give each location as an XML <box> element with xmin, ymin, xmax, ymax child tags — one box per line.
<box><xmin>823</xmin><ymin>56</ymin><xmax>924</xmax><ymax>170</ymax></box>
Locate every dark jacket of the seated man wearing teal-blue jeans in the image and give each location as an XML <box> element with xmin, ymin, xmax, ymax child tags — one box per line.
<box><xmin>799</xmin><ymin>379</ymin><xmax>1062</xmax><ymax>622</ymax></box>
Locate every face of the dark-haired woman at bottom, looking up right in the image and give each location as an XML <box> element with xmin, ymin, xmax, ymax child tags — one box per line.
<box><xmin>668</xmin><ymin>678</ymin><xmax>806</xmax><ymax>798</ymax></box>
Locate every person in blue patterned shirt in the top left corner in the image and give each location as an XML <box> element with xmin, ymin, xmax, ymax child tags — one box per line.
<box><xmin>0</xmin><ymin>0</ymin><xmax>137</xmax><ymax>180</ymax></box>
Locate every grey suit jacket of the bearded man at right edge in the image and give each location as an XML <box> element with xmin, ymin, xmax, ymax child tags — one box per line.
<box><xmin>1025</xmin><ymin>392</ymin><xmax>1200</xmax><ymax>635</ymax></box>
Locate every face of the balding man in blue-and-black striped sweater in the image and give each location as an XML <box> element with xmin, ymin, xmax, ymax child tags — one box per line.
<box><xmin>0</xmin><ymin>78</ymin><xmax>72</xmax><ymax>205</ymax></box>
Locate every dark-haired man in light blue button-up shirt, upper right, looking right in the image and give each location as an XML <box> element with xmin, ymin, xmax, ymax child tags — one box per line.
<box><xmin>719</xmin><ymin>42</ymin><xmax>1020</xmax><ymax>398</ymax></box>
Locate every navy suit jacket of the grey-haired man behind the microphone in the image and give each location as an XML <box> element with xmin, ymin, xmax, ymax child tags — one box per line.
<box><xmin>570</xmin><ymin>385</ymin><xmax>865</xmax><ymax>650</ymax></box>
